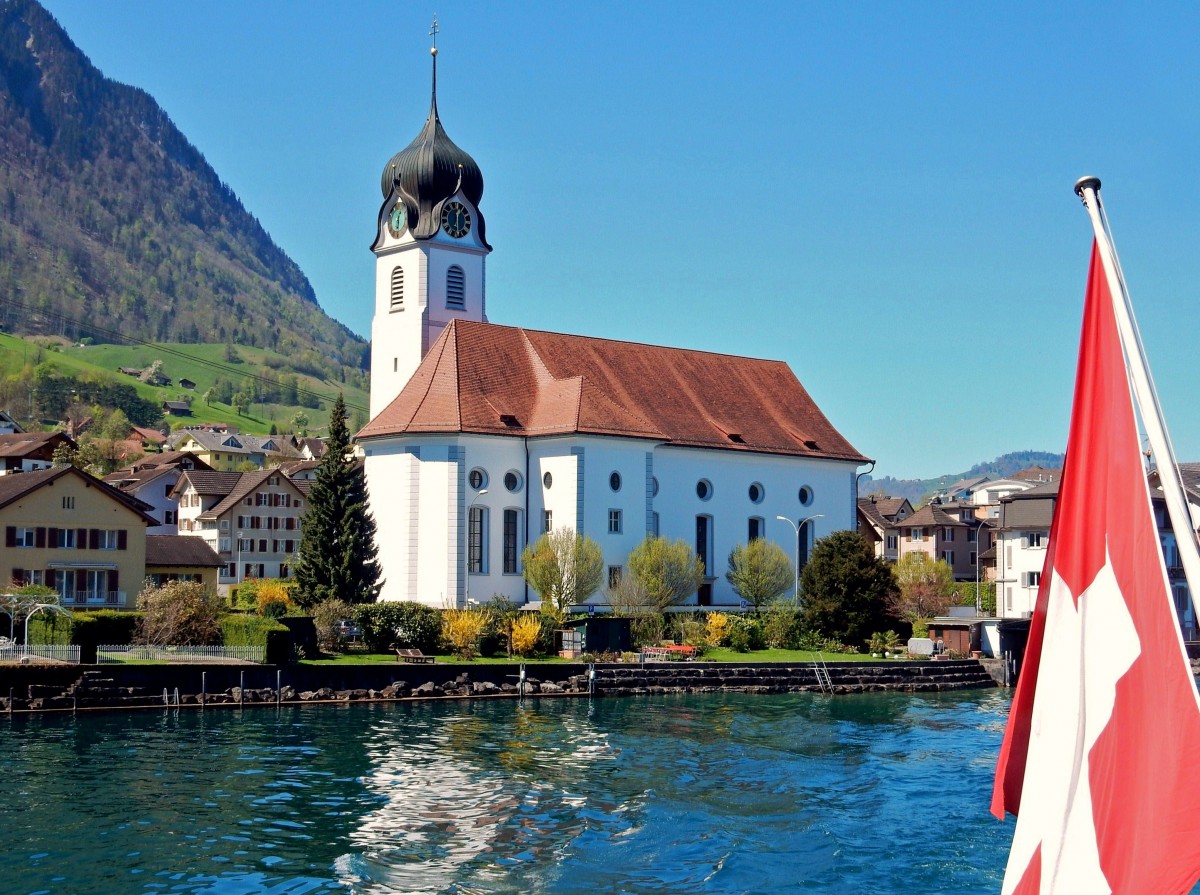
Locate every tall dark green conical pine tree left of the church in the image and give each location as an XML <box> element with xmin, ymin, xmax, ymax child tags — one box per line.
<box><xmin>295</xmin><ymin>395</ymin><xmax>383</xmax><ymax>606</ymax></box>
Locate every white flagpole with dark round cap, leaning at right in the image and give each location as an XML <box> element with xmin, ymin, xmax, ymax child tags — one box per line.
<box><xmin>1075</xmin><ymin>176</ymin><xmax>1200</xmax><ymax>645</ymax></box>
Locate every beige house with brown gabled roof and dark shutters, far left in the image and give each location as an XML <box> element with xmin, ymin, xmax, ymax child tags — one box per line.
<box><xmin>0</xmin><ymin>465</ymin><xmax>156</xmax><ymax>609</ymax></box>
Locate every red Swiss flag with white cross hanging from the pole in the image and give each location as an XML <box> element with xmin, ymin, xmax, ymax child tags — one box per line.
<box><xmin>991</xmin><ymin>244</ymin><xmax>1200</xmax><ymax>895</ymax></box>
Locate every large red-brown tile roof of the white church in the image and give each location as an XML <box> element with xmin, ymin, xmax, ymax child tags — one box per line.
<box><xmin>358</xmin><ymin>320</ymin><xmax>865</xmax><ymax>463</ymax></box>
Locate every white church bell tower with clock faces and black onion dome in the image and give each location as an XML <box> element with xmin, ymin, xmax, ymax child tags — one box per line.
<box><xmin>371</xmin><ymin>19</ymin><xmax>492</xmax><ymax>419</ymax></box>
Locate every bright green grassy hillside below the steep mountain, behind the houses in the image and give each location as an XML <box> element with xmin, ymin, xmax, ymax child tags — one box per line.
<box><xmin>0</xmin><ymin>334</ymin><xmax>368</xmax><ymax>433</ymax></box>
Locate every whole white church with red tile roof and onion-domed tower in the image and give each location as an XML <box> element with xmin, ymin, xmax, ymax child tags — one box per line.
<box><xmin>358</xmin><ymin>40</ymin><xmax>870</xmax><ymax>607</ymax></box>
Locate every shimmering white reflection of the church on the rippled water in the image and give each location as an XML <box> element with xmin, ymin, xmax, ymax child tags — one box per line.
<box><xmin>335</xmin><ymin>704</ymin><xmax>632</xmax><ymax>893</ymax></box>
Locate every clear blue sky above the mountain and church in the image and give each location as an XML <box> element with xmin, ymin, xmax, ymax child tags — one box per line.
<box><xmin>47</xmin><ymin>0</ymin><xmax>1200</xmax><ymax>477</ymax></box>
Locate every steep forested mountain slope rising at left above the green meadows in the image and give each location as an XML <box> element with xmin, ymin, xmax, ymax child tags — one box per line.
<box><xmin>0</xmin><ymin>0</ymin><xmax>367</xmax><ymax>380</ymax></box>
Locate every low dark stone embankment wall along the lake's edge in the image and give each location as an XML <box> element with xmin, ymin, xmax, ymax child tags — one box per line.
<box><xmin>0</xmin><ymin>660</ymin><xmax>995</xmax><ymax>711</ymax></box>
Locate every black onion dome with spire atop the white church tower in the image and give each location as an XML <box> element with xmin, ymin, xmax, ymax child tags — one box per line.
<box><xmin>379</xmin><ymin>56</ymin><xmax>487</xmax><ymax>245</ymax></box>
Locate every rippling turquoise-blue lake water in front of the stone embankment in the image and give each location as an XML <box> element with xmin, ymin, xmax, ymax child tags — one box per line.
<box><xmin>0</xmin><ymin>691</ymin><xmax>1012</xmax><ymax>895</ymax></box>
